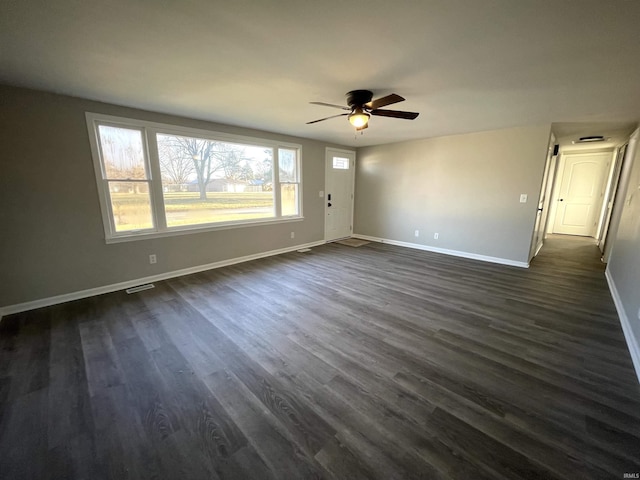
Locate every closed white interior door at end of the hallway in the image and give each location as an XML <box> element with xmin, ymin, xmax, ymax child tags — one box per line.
<box><xmin>553</xmin><ymin>152</ymin><xmax>611</xmax><ymax>237</ymax></box>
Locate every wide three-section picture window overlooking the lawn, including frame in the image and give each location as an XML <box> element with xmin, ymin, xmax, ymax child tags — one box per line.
<box><xmin>87</xmin><ymin>113</ymin><xmax>302</xmax><ymax>241</ymax></box>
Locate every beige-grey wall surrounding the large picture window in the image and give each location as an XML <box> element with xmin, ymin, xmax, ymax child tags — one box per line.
<box><xmin>0</xmin><ymin>86</ymin><xmax>350</xmax><ymax>306</ymax></box>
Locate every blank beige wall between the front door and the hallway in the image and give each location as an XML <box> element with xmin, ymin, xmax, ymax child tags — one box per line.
<box><xmin>354</xmin><ymin>125</ymin><xmax>550</xmax><ymax>263</ymax></box>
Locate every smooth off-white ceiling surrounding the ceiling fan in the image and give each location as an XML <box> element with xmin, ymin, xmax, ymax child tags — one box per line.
<box><xmin>0</xmin><ymin>0</ymin><xmax>640</xmax><ymax>146</ymax></box>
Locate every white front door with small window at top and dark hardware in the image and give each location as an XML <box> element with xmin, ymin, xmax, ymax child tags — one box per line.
<box><xmin>324</xmin><ymin>148</ymin><xmax>356</xmax><ymax>242</ymax></box>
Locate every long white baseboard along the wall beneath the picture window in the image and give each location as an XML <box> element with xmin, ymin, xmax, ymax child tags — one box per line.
<box><xmin>0</xmin><ymin>240</ymin><xmax>326</xmax><ymax>320</ymax></box>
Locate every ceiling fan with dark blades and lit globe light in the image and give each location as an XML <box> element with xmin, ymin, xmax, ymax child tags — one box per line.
<box><xmin>307</xmin><ymin>90</ymin><xmax>419</xmax><ymax>130</ymax></box>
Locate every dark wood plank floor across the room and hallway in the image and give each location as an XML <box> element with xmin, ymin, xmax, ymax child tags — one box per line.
<box><xmin>0</xmin><ymin>237</ymin><xmax>640</xmax><ymax>480</ymax></box>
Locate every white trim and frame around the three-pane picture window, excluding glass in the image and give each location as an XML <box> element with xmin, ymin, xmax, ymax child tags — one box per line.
<box><xmin>85</xmin><ymin>112</ymin><xmax>304</xmax><ymax>243</ymax></box>
